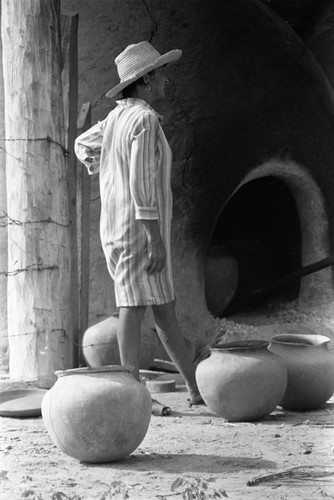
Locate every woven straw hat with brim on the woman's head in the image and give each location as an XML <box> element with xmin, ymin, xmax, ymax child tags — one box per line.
<box><xmin>106</xmin><ymin>42</ymin><xmax>182</xmax><ymax>97</ymax></box>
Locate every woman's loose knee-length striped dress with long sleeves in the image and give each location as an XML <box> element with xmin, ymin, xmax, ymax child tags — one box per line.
<box><xmin>75</xmin><ymin>98</ymin><xmax>174</xmax><ymax>307</ymax></box>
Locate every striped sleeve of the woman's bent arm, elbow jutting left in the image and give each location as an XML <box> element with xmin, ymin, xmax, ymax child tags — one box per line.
<box><xmin>74</xmin><ymin>122</ymin><xmax>103</xmax><ymax>175</ymax></box>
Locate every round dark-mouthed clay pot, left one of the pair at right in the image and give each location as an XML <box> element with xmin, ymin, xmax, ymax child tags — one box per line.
<box><xmin>196</xmin><ymin>340</ymin><xmax>287</xmax><ymax>422</ymax></box>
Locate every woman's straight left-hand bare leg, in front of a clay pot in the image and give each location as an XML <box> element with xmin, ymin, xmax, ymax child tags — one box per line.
<box><xmin>117</xmin><ymin>306</ymin><xmax>146</xmax><ymax>381</ymax></box>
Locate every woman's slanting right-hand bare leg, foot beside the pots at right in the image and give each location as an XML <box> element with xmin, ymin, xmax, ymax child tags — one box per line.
<box><xmin>152</xmin><ymin>302</ymin><xmax>203</xmax><ymax>404</ymax></box>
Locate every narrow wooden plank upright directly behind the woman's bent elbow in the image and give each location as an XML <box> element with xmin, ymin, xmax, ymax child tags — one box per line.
<box><xmin>77</xmin><ymin>102</ymin><xmax>91</xmax><ymax>365</ymax></box>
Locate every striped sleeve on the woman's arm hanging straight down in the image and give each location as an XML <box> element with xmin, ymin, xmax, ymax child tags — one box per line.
<box><xmin>129</xmin><ymin>113</ymin><xmax>159</xmax><ymax>220</ymax></box>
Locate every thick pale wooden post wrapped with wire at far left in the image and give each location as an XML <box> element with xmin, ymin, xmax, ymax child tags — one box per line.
<box><xmin>1</xmin><ymin>0</ymin><xmax>73</xmax><ymax>380</ymax></box>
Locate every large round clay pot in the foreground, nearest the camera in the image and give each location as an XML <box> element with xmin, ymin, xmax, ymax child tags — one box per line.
<box><xmin>42</xmin><ymin>366</ymin><xmax>152</xmax><ymax>462</ymax></box>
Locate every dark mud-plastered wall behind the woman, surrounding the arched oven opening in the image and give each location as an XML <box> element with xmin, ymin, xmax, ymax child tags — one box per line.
<box><xmin>62</xmin><ymin>0</ymin><xmax>334</xmax><ymax>344</ymax></box>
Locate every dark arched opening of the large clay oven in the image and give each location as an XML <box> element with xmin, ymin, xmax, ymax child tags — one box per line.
<box><xmin>206</xmin><ymin>176</ymin><xmax>301</xmax><ymax>316</ymax></box>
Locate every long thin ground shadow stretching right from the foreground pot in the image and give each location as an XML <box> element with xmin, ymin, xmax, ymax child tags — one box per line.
<box><xmin>85</xmin><ymin>450</ymin><xmax>276</xmax><ymax>474</ymax></box>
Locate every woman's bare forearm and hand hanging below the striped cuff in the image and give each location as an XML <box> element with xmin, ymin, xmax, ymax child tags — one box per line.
<box><xmin>142</xmin><ymin>220</ymin><xmax>166</xmax><ymax>274</ymax></box>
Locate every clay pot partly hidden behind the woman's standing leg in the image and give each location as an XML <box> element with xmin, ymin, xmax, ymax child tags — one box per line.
<box><xmin>82</xmin><ymin>316</ymin><xmax>159</xmax><ymax>370</ymax></box>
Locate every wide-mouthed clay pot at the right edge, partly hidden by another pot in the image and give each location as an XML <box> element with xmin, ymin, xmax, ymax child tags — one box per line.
<box><xmin>269</xmin><ymin>334</ymin><xmax>334</xmax><ymax>410</ymax></box>
